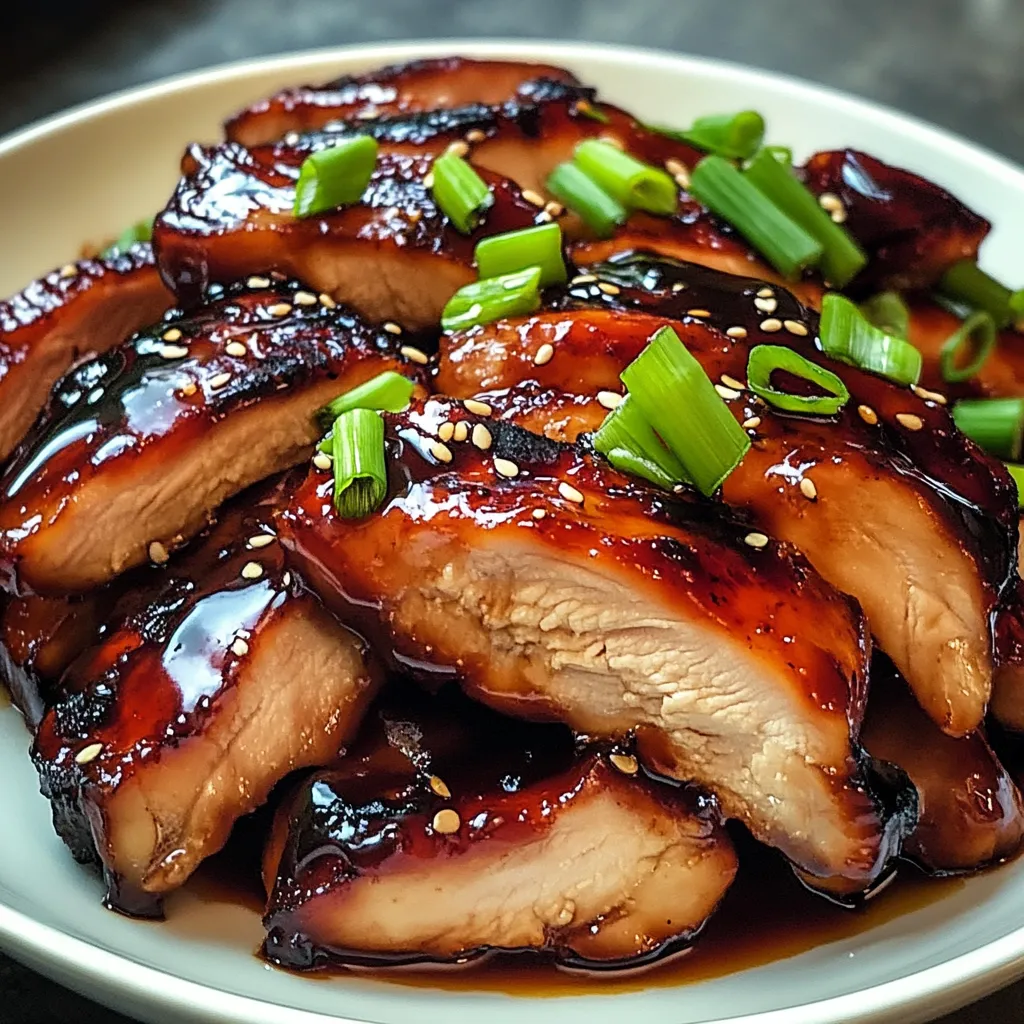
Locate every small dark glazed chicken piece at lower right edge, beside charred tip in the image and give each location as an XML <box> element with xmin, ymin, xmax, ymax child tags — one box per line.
<box><xmin>861</xmin><ymin>659</ymin><xmax>1024</xmax><ymax>871</ymax></box>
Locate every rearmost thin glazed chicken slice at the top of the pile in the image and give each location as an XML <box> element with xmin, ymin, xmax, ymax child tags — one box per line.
<box><xmin>224</xmin><ymin>57</ymin><xmax>577</xmax><ymax>145</ymax></box>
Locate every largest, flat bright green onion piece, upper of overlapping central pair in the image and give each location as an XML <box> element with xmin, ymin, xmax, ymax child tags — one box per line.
<box><xmin>622</xmin><ymin>327</ymin><xmax>751</xmax><ymax>495</ymax></box>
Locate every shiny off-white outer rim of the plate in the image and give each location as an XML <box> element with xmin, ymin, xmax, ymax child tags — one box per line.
<box><xmin>0</xmin><ymin>37</ymin><xmax>1024</xmax><ymax>1024</ymax></box>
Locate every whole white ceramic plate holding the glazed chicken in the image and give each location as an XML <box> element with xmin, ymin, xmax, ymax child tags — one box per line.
<box><xmin>0</xmin><ymin>42</ymin><xmax>1024</xmax><ymax>1024</ymax></box>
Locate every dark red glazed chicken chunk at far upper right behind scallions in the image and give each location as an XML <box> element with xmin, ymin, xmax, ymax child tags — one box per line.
<box><xmin>803</xmin><ymin>150</ymin><xmax>990</xmax><ymax>290</ymax></box>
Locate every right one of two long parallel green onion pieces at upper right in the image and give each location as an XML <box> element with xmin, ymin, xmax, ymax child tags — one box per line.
<box><xmin>743</xmin><ymin>151</ymin><xmax>867</xmax><ymax>288</ymax></box>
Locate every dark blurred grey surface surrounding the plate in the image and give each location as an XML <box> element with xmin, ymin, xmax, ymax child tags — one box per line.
<box><xmin>0</xmin><ymin>0</ymin><xmax>1024</xmax><ymax>1024</ymax></box>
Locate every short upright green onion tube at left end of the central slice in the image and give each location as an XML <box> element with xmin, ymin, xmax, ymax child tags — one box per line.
<box><xmin>331</xmin><ymin>409</ymin><xmax>387</xmax><ymax>519</ymax></box>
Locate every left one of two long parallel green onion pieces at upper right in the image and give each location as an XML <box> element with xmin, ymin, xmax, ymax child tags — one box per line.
<box><xmin>690</xmin><ymin>157</ymin><xmax>823</xmax><ymax>278</ymax></box>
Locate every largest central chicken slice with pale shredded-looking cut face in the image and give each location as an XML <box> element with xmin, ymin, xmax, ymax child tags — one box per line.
<box><xmin>282</xmin><ymin>399</ymin><xmax>917</xmax><ymax>890</ymax></box>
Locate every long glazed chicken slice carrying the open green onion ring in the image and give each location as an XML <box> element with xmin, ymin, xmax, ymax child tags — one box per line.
<box><xmin>437</xmin><ymin>258</ymin><xmax>1016</xmax><ymax>735</ymax></box>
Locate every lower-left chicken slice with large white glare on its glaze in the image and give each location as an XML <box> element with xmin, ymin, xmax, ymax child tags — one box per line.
<box><xmin>33</xmin><ymin>484</ymin><xmax>382</xmax><ymax>916</ymax></box>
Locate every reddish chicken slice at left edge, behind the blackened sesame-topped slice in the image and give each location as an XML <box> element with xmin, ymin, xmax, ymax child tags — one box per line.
<box><xmin>0</xmin><ymin>245</ymin><xmax>171</xmax><ymax>463</ymax></box>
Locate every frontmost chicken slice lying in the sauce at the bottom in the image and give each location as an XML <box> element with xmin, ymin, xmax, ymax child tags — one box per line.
<box><xmin>264</xmin><ymin>694</ymin><xmax>736</xmax><ymax>970</ymax></box>
